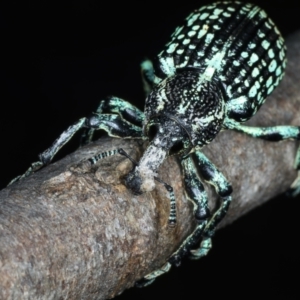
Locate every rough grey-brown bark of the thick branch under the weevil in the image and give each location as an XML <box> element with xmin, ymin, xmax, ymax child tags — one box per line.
<box><xmin>0</xmin><ymin>33</ymin><xmax>300</xmax><ymax>299</ymax></box>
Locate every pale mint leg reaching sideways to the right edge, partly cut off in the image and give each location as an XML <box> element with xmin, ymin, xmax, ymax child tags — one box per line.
<box><xmin>225</xmin><ymin>119</ymin><xmax>300</xmax><ymax>197</ymax></box>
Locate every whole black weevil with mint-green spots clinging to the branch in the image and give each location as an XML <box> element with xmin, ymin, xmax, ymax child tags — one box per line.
<box><xmin>11</xmin><ymin>1</ymin><xmax>300</xmax><ymax>286</ymax></box>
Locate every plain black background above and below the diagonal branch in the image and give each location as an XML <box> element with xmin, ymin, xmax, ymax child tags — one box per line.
<box><xmin>0</xmin><ymin>0</ymin><xmax>300</xmax><ymax>299</ymax></box>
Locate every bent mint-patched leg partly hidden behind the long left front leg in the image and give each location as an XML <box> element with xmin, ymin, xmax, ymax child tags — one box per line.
<box><xmin>80</xmin><ymin>96</ymin><xmax>145</xmax><ymax>146</ymax></box>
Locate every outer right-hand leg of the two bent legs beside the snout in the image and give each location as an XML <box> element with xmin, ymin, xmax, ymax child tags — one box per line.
<box><xmin>192</xmin><ymin>151</ymin><xmax>232</xmax><ymax>259</ymax></box>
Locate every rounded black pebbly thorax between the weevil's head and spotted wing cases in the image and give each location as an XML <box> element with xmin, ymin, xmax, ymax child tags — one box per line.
<box><xmin>145</xmin><ymin>69</ymin><xmax>225</xmax><ymax>147</ymax></box>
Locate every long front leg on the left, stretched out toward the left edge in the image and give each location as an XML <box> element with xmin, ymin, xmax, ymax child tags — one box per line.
<box><xmin>8</xmin><ymin>114</ymin><xmax>143</xmax><ymax>185</ymax></box>
